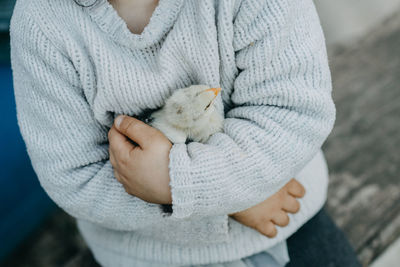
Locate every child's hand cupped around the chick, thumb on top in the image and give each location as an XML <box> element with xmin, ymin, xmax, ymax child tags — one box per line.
<box><xmin>108</xmin><ymin>116</ymin><xmax>172</xmax><ymax>204</ymax></box>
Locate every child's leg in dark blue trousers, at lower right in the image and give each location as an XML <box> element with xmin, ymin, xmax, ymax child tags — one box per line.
<box><xmin>287</xmin><ymin>209</ymin><xmax>361</xmax><ymax>267</ymax></box>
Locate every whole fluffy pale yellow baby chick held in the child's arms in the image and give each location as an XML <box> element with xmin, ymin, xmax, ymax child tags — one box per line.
<box><xmin>149</xmin><ymin>84</ymin><xmax>224</xmax><ymax>143</ymax></box>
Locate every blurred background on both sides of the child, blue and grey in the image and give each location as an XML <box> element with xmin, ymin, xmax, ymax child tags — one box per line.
<box><xmin>0</xmin><ymin>0</ymin><xmax>400</xmax><ymax>267</ymax></box>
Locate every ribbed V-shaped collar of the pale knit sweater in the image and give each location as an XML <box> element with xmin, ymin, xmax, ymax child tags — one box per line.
<box><xmin>83</xmin><ymin>0</ymin><xmax>184</xmax><ymax>49</ymax></box>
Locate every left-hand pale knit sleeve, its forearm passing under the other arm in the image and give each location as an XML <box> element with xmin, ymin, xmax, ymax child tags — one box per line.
<box><xmin>10</xmin><ymin>11</ymin><xmax>227</xmax><ymax>236</ymax></box>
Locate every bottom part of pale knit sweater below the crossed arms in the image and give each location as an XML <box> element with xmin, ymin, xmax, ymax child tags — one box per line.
<box><xmin>78</xmin><ymin>152</ymin><xmax>328</xmax><ymax>267</ymax></box>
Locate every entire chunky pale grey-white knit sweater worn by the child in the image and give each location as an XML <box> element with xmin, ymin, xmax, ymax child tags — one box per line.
<box><xmin>10</xmin><ymin>0</ymin><xmax>335</xmax><ymax>266</ymax></box>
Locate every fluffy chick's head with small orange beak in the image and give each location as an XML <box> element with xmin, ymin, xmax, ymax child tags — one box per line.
<box><xmin>164</xmin><ymin>85</ymin><xmax>221</xmax><ymax>128</ymax></box>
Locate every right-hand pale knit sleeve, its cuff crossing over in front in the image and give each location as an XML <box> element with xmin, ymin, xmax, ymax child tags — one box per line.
<box><xmin>169</xmin><ymin>0</ymin><xmax>335</xmax><ymax>218</ymax></box>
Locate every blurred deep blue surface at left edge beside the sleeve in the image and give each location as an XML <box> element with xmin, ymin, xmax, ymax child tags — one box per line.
<box><xmin>0</xmin><ymin>65</ymin><xmax>56</xmax><ymax>261</ymax></box>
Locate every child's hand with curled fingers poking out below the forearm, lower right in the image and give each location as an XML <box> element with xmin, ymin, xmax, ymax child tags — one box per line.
<box><xmin>230</xmin><ymin>178</ymin><xmax>305</xmax><ymax>237</ymax></box>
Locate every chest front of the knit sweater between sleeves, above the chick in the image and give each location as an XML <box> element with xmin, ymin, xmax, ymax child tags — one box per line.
<box><xmin>54</xmin><ymin>0</ymin><xmax>241</xmax><ymax>129</ymax></box>
